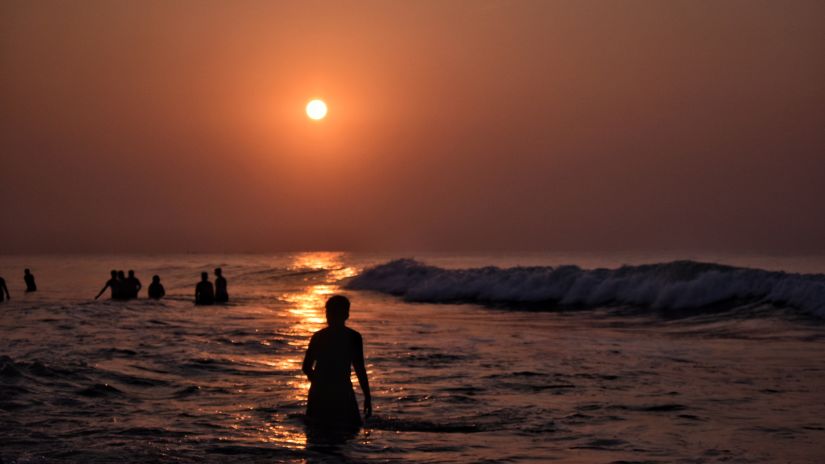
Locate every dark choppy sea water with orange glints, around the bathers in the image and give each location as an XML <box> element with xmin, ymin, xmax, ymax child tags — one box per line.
<box><xmin>0</xmin><ymin>253</ymin><xmax>825</xmax><ymax>463</ymax></box>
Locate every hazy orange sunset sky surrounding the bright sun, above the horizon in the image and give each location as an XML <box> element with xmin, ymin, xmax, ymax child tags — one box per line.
<box><xmin>0</xmin><ymin>0</ymin><xmax>825</xmax><ymax>253</ymax></box>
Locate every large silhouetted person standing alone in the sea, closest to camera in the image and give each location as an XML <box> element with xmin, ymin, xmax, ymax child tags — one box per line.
<box><xmin>303</xmin><ymin>295</ymin><xmax>372</xmax><ymax>431</ymax></box>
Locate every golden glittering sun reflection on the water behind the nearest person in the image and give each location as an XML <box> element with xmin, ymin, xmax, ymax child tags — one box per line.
<box><xmin>261</xmin><ymin>252</ymin><xmax>357</xmax><ymax>449</ymax></box>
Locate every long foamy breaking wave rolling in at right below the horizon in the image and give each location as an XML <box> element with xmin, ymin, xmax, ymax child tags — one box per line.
<box><xmin>347</xmin><ymin>259</ymin><xmax>825</xmax><ymax>317</ymax></box>
